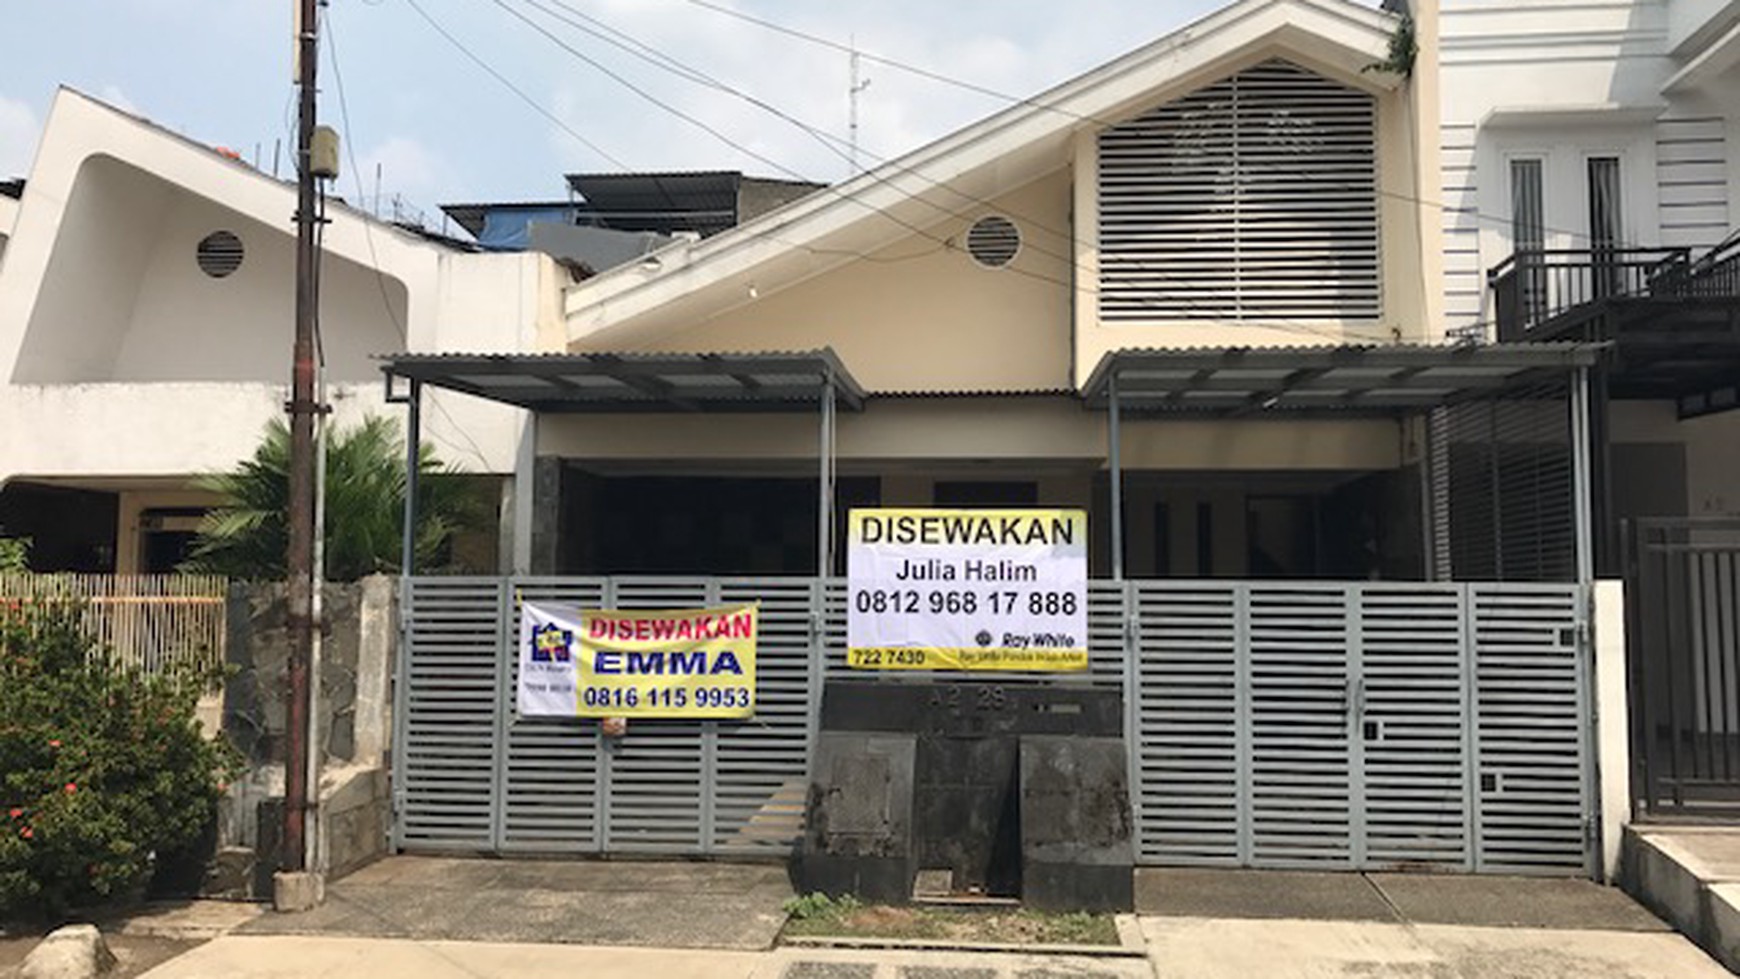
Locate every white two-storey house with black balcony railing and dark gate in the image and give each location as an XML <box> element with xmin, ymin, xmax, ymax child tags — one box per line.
<box><xmin>1442</xmin><ymin>0</ymin><xmax>1740</xmax><ymax>821</ymax></box>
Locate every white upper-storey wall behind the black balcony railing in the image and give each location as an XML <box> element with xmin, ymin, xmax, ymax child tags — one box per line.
<box><xmin>1441</xmin><ymin>0</ymin><xmax>1740</xmax><ymax>337</ymax></box>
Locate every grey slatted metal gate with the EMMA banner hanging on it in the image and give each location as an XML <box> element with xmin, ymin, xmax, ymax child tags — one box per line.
<box><xmin>393</xmin><ymin>577</ymin><xmax>823</xmax><ymax>856</ymax></box>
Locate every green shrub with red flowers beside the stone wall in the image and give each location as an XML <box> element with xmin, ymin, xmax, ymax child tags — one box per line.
<box><xmin>0</xmin><ymin>602</ymin><xmax>238</xmax><ymax>920</ymax></box>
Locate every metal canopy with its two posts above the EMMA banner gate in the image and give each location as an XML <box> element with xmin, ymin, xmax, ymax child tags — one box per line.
<box><xmin>381</xmin><ymin>348</ymin><xmax>865</xmax><ymax>579</ymax></box>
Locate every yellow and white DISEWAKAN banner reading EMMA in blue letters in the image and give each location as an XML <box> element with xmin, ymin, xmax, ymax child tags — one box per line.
<box><xmin>519</xmin><ymin>602</ymin><xmax>757</xmax><ymax>718</ymax></box>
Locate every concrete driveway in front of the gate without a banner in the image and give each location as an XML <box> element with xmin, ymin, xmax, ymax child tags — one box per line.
<box><xmin>1136</xmin><ymin>869</ymin><xmax>1730</xmax><ymax>979</ymax></box>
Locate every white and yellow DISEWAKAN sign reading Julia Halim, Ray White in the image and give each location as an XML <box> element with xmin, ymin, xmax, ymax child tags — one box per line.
<box><xmin>846</xmin><ymin>509</ymin><xmax>1088</xmax><ymax>669</ymax></box>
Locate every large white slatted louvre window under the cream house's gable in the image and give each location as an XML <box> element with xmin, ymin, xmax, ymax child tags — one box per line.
<box><xmin>1098</xmin><ymin>59</ymin><xmax>1382</xmax><ymax>322</ymax></box>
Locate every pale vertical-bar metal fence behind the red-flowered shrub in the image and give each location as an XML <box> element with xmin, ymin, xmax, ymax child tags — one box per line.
<box><xmin>0</xmin><ymin>572</ymin><xmax>230</xmax><ymax>671</ymax></box>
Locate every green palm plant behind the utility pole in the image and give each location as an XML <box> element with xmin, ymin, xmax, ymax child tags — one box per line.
<box><xmin>183</xmin><ymin>417</ymin><xmax>482</xmax><ymax>581</ymax></box>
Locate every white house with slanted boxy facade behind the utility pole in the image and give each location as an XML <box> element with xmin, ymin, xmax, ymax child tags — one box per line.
<box><xmin>0</xmin><ymin>89</ymin><xmax>567</xmax><ymax>572</ymax></box>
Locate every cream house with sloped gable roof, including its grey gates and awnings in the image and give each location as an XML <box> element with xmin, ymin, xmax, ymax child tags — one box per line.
<box><xmin>374</xmin><ymin>0</ymin><xmax>1625</xmax><ymax>892</ymax></box>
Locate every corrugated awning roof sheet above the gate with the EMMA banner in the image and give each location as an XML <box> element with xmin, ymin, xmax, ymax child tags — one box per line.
<box><xmin>381</xmin><ymin>348</ymin><xmax>865</xmax><ymax>412</ymax></box>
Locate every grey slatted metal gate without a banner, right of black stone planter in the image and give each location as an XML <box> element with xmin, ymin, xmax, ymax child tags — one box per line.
<box><xmin>1129</xmin><ymin>581</ymin><xmax>1594</xmax><ymax>873</ymax></box>
